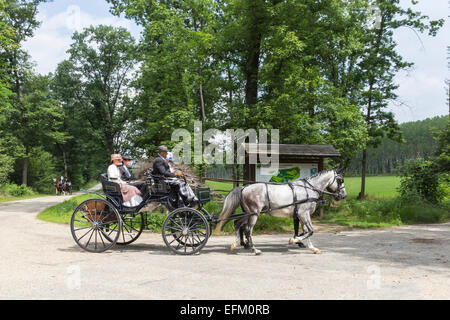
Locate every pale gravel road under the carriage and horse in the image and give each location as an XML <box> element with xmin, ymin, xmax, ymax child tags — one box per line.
<box><xmin>0</xmin><ymin>192</ymin><xmax>450</xmax><ymax>300</ymax></box>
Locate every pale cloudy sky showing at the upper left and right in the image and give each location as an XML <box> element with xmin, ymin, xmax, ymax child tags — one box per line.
<box><xmin>24</xmin><ymin>0</ymin><xmax>450</xmax><ymax>123</ymax></box>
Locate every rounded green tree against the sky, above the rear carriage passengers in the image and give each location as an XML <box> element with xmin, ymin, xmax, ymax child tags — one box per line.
<box><xmin>59</xmin><ymin>25</ymin><xmax>138</xmax><ymax>153</ymax></box>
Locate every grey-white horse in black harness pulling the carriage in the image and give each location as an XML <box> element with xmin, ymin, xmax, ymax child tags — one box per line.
<box><xmin>216</xmin><ymin>169</ymin><xmax>347</xmax><ymax>255</ymax></box>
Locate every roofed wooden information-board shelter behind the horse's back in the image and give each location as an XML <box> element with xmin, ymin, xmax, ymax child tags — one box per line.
<box><xmin>244</xmin><ymin>143</ymin><xmax>340</xmax><ymax>182</ymax></box>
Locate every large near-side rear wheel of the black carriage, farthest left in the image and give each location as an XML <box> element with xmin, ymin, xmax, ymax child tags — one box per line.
<box><xmin>70</xmin><ymin>199</ymin><xmax>122</xmax><ymax>252</ymax></box>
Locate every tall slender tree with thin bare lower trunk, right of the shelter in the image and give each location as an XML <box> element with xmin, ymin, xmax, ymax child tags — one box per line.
<box><xmin>358</xmin><ymin>0</ymin><xmax>443</xmax><ymax>198</ymax></box>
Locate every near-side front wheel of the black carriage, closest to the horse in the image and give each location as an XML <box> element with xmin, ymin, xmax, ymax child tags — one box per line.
<box><xmin>162</xmin><ymin>208</ymin><xmax>210</xmax><ymax>255</ymax></box>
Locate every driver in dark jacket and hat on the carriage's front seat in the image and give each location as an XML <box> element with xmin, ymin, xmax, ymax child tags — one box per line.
<box><xmin>152</xmin><ymin>146</ymin><xmax>197</xmax><ymax>206</ymax></box>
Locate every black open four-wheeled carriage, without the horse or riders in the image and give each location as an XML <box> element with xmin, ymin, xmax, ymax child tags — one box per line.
<box><xmin>70</xmin><ymin>172</ymin><xmax>221</xmax><ymax>255</ymax></box>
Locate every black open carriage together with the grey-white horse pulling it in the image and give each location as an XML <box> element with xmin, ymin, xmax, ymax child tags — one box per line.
<box><xmin>70</xmin><ymin>170</ymin><xmax>346</xmax><ymax>255</ymax></box>
